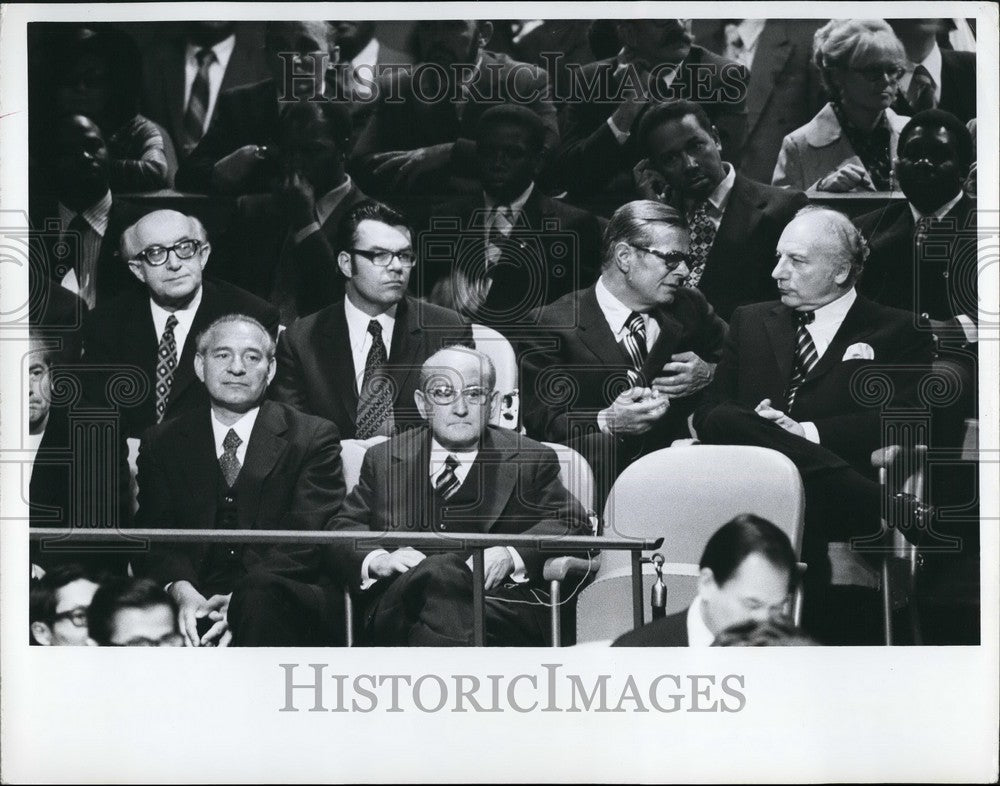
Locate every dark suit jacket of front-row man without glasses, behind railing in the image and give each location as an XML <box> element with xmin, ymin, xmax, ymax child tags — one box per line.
<box><xmin>136</xmin><ymin>401</ymin><xmax>345</xmax><ymax>597</ymax></box>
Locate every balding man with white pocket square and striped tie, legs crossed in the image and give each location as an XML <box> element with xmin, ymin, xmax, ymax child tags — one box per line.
<box><xmin>694</xmin><ymin>208</ymin><xmax>932</xmax><ymax>584</ymax></box>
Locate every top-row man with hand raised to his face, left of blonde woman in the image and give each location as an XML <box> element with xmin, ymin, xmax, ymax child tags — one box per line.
<box><xmin>556</xmin><ymin>19</ymin><xmax>749</xmax><ymax>207</ymax></box>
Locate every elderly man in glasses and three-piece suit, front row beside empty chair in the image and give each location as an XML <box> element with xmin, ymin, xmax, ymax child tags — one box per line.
<box><xmin>328</xmin><ymin>347</ymin><xmax>589</xmax><ymax>646</ymax></box>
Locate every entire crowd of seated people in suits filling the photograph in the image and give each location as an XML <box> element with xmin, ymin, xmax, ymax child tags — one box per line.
<box><xmin>24</xmin><ymin>19</ymin><xmax>979</xmax><ymax>646</ymax></box>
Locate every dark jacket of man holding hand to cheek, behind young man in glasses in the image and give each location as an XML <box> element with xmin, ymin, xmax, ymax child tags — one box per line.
<box><xmin>212</xmin><ymin>184</ymin><xmax>368</xmax><ymax>318</ymax></box>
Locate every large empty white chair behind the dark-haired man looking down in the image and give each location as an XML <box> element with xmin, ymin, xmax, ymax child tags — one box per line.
<box><xmin>577</xmin><ymin>445</ymin><xmax>805</xmax><ymax>641</ymax></box>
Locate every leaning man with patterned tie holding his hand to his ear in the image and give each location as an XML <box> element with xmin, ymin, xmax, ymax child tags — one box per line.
<box><xmin>636</xmin><ymin>101</ymin><xmax>808</xmax><ymax>319</ymax></box>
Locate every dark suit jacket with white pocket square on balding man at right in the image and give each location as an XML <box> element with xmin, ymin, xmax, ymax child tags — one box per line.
<box><xmin>694</xmin><ymin>295</ymin><xmax>932</xmax><ymax>472</ymax></box>
